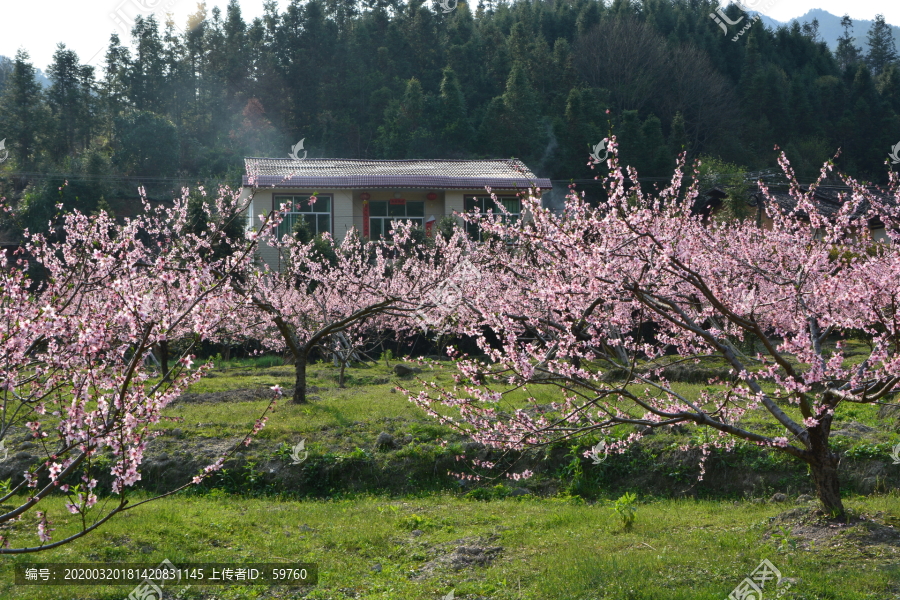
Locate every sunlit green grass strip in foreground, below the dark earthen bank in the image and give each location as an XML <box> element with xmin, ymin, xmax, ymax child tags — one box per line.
<box><xmin>0</xmin><ymin>495</ymin><xmax>900</xmax><ymax>600</ymax></box>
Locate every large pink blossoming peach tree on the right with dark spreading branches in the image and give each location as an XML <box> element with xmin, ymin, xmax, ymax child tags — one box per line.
<box><xmin>409</xmin><ymin>142</ymin><xmax>900</xmax><ymax>516</ymax></box>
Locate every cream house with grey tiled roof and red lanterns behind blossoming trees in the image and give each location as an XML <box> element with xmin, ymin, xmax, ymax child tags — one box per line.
<box><xmin>243</xmin><ymin>157</ymin><xmax>552</xmax><ymax>266</ymax></box>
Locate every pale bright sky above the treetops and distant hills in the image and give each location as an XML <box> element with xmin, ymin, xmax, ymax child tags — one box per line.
<box><xmin>0</xmin><ymin>0</ymin><xmax>900</xmax><ymax>76</ymax></box>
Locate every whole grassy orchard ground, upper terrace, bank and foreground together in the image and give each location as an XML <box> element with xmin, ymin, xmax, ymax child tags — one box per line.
<box><xmin>0</xmin><ymin>354</ymin><xmax>900</xmax><ymax>600</ymax></box>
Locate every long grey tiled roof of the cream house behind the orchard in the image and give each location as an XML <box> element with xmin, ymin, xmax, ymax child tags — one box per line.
<box><xmin>243</xmin><ymin>157</ymin><xmax>553</xmax><ymax>190</ymax></box>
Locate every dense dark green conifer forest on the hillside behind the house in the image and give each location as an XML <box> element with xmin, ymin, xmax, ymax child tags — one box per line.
<box><xmin>0</xmin><ymin>0</ymin><xmax>900</xmax><ymax>233</ymax></box>
